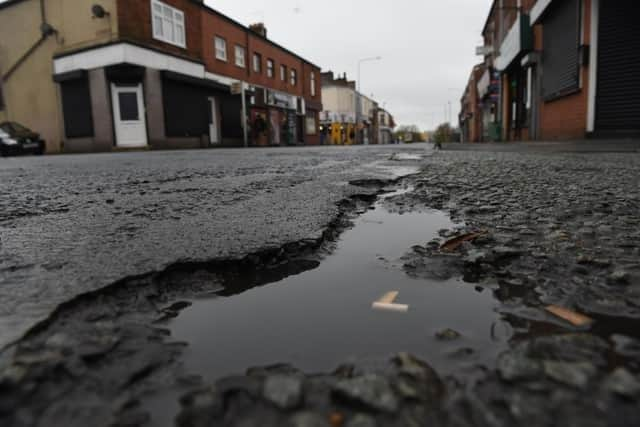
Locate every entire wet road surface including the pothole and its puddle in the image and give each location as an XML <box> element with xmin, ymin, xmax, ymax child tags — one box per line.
<box><xmin>0</xmin><ymin>144</ymin><xmax>640</xmax><ymax>427</ymax></box>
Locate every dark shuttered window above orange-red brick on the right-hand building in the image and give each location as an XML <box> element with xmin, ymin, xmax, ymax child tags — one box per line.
<box><xmin>542</xmin><ymin>0</ymin><xmax>580</xmax><ymax>100</ymax></box>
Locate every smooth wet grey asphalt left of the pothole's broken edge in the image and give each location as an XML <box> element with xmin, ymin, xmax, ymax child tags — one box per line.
<box><xmin>0</xmin><ymin>145</ymin><xmax>430</xmax><ymax>348</ymax></box>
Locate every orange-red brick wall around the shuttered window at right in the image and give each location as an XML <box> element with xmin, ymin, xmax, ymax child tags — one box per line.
<box><xmin>535</xmin><ymin>0</ymin><xmax>591</xmax><ymax>140</ymax></box>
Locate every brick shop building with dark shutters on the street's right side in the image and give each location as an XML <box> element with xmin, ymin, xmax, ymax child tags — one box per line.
<box><xmin>470</xmin><ymin>0</ymin><xmax>640</xmax><ymax>141</ymax></box>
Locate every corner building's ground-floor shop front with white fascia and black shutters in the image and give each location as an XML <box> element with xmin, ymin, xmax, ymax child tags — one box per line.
<box><xmin>53</xmin><ymin>43</ymin><xmax>235</xmax><ymax>152</ymax></box>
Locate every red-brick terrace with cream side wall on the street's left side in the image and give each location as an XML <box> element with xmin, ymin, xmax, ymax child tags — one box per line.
<box><xmin>0</xmin><ymin>0</ymin><xmax>322</xmax><ymax>152</ymax></box>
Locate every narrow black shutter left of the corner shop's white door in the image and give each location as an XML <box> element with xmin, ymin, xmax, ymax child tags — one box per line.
<box><xmin>60</xmin><ymin>74</ymin><xmax>93</xmax><ymax>138</ymax></box>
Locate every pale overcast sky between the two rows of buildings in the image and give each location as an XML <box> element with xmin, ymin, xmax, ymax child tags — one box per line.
<box><xmin>206</xmin><ymin>0</ymin><xmax>491</xmax><ymax>129</ymax></box>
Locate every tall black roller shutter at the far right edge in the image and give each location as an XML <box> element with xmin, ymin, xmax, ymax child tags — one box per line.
<box><xmin>596</xmin><ymin>0</ymin><xmax>640</xmax><ymax>133</ymax></box>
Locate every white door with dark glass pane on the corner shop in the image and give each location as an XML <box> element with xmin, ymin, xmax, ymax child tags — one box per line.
<box><xmin>111</xmin><ymin>84</ymin><xmax>147</xmax><ymax>148</ymax></box>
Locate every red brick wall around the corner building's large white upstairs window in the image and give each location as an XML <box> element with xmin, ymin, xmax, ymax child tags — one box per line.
<box><xmin>117</xmin><ymin>0</ymin><xmax>202</xmax><ymax>61</ymax></box>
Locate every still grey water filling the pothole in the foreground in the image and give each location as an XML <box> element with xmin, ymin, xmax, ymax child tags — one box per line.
<box><xmin>170</xmin><ymin>187</ymin><xmax>504</xmax><ymax>381</ymax></box>
